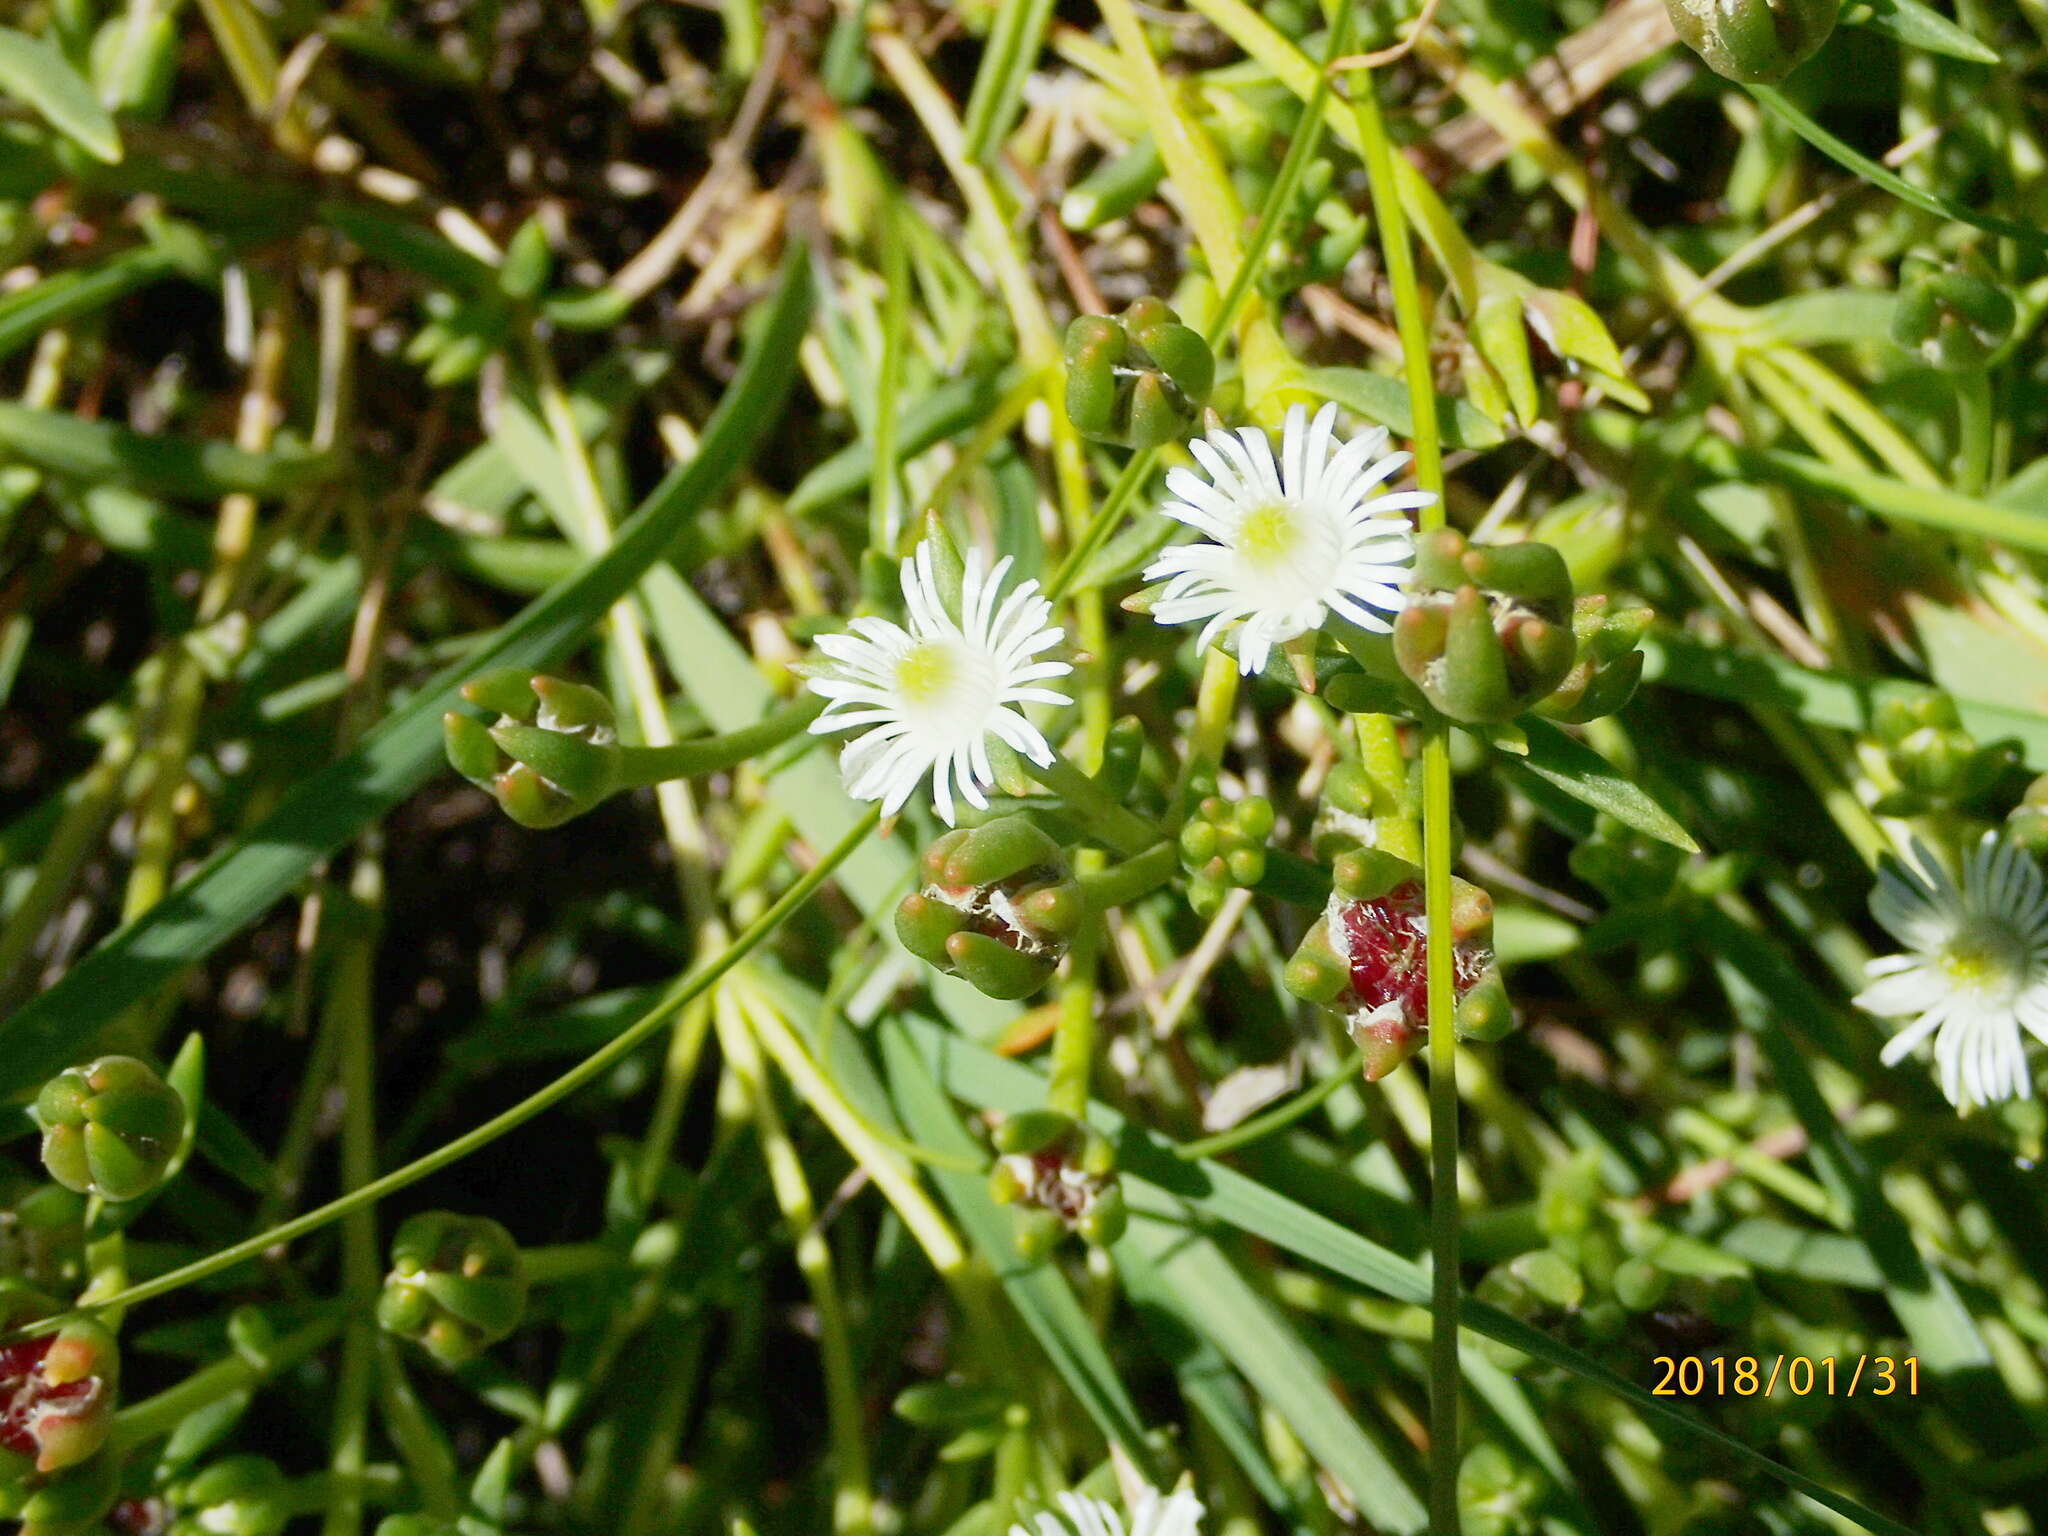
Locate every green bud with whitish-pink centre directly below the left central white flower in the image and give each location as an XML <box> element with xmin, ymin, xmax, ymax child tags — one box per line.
<box><xmin>897</xmin><ymin>815</ymin><xmax>1085</xmax><ymax>999</ymax></box>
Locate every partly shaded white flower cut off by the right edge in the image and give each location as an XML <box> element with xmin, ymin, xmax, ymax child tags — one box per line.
<box><xmin>1855</xmin><ymin>831</ymin><xmax>2048</xmax><ymax>1108</ymax></box>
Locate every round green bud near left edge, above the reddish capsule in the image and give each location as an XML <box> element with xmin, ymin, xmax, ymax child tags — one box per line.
<box><xmin>31</xmin><ymin>1057</ymin><xmax>184</xmax><ymax>1200</ymax></box>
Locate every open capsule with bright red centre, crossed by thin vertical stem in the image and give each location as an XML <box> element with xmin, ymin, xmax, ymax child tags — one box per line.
<box><xmin>1284</xmin><ymin>848</ymin><xmax>1513</xmax><ymax>1081</ymax></box>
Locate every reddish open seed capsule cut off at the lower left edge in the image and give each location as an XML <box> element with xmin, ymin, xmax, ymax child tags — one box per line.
<box><xmin>0</xmin><ymin>1282</ymin><xmax>121</xmax><ymax>1475</ymax></box>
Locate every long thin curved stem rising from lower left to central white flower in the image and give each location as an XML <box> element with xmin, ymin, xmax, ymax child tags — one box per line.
<box><xmin>0</xmin><ymin>809</ymin><xmax>881</xmax><ymax>1346</ymax></box>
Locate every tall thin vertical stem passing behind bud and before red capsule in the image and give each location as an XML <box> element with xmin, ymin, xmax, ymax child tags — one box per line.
<box><xmin>1339</xmin><ymin>36</ymin><xmax>1458</xmax><ymax>1536</ymax></box>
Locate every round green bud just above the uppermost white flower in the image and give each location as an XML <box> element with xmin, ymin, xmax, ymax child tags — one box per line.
<box><xmin>1067</xmin><ymin>297</ymin><xmax>1217</xmax><ymax>449</ymax></box>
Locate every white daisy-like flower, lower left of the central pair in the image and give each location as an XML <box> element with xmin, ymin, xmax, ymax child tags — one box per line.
<box><xmin>807</xmin><ymin>541</ymin><xmax>1073</xmax><ymax>827</ymax></box>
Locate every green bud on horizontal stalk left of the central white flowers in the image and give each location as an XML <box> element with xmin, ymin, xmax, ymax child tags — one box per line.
<box><xmin>442</xmin><ymin>668</ymin><xmax>623</xmax><ymax>827</ymax></box>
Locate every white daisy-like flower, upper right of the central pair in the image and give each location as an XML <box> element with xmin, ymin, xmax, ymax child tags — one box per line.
<box><xmin>1145</xmin><ymin>406</ymin><xmax>1436</xmax><ymax>674</ymax></box>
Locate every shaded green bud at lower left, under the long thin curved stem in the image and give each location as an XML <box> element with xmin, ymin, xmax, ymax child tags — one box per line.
<box><xmin>377</xmin><ymin>1210</ymin><xmax>526</xmax><ymax>1366</ymax></box>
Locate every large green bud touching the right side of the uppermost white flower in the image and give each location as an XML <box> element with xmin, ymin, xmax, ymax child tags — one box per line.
<box><xmin>1395</xmin><ymin>528</ymin><xmax>1577</xmax><ymax>725</ymax></box>
